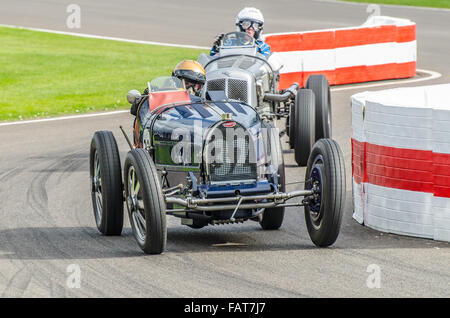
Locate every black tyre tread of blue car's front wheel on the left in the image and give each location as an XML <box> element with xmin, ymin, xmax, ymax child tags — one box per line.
<box><xmin>124</xmin><ymin>149</ymin><xmax>167</xmax><ymax>254</ymax></box>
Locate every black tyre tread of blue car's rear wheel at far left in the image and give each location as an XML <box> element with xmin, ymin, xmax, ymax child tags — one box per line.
<box><xmin>90</xmin><ymin>131</ymin><xmax>123</xmax><ymax>235</ymax></box>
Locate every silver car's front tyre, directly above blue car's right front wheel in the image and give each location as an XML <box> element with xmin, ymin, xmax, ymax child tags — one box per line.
<box><xmin>294</xmin><ymin>89</ymin><xmax>315</xmax><ymax>167</ymax></box>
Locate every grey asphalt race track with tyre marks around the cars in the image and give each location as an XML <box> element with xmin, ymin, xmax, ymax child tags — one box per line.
<box><xmin>0</xmin><ymin>0</ymin><xmax>450</xmax><ymax>297</ymax></box>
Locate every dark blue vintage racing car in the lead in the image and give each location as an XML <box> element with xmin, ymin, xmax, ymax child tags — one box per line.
<box><xmin>90</xmin><ymin>74</ymin><xmax>346</xmax><ymax>254</ymax></box>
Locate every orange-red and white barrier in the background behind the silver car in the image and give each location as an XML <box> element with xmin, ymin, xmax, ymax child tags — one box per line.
<box><xmin>264</xmin><ymin>16</ymin><xmax>417</xmax><ymax>89</ymax></box>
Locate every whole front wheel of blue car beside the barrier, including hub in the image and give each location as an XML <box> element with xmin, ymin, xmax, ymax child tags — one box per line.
<box><xmin>305</xmin><ymin>138</ymin><xmax>346</xmax><ymax>247</ymax></box>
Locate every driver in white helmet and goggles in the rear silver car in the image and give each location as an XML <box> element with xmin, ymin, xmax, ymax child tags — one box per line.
<box><xmin>209</xmin><ymin>7</ymin><xmax>270</xmax><ymax>57</ymax></box>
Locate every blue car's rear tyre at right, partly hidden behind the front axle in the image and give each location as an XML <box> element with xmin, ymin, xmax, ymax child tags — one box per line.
<box><xmin>259</xmin><ymin>123</ymin><xmax>286</xmax><ymax>230</ymax></box>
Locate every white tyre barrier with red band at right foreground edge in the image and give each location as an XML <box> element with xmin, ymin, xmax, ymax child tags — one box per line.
<box><xmin>351</xmin><ymin>84</ymin><xmax>450</xmax><ymax>242</ymax></box>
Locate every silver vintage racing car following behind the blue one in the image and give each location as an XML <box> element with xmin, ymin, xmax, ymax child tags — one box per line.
<box><xmin>197</xmin><ymin>32</ymin><xmax>331</xmax><ymax>166</ymax></box>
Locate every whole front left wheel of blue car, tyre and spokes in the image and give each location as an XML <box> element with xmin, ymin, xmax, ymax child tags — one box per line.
<box><xmin>123</xmin><ymin>149</ymin><xmax>167</xmax><ymax>254</ymax></box>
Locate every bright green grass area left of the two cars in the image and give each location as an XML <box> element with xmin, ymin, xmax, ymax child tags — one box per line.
<box><xmin>0</xmin><ymin>27</ymin><xmax>204</xmax><ymax>121</ymax></box>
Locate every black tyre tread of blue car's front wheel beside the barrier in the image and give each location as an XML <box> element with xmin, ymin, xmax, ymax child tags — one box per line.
<box><xmin>305</xmin><ymin>139</ymin><xmax>346</xmax><ymax>247</ymax></box>
